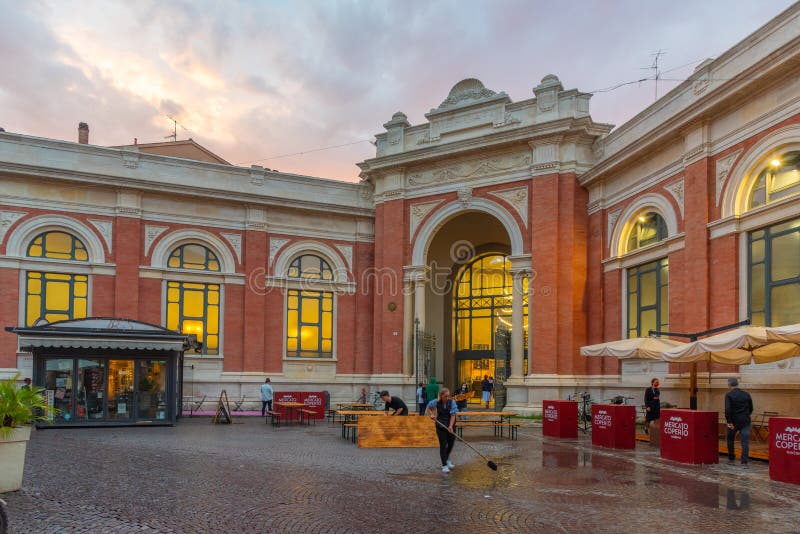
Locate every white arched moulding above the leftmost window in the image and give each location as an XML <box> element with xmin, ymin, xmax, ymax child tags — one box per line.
<box><xmin>6</xmin><ymin>214</ymin><xmax>106</xmax><ymax>263</ymax></box>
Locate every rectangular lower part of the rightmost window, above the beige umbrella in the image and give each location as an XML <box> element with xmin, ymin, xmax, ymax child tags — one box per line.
<box><xmin>748</xmin><ymin>218</ymin><xmax>800</xmax><ymax>326</ymax></box>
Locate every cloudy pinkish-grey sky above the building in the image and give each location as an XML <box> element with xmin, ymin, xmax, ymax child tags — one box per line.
<box><xmin>0</xmin><ymin>0</ymin><xmax>792</xmax><ymax>181</ymax></box>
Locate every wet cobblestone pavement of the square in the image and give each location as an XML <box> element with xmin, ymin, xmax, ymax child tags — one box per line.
<box><xmin>3</xmin><ymin>417</ymin><xmax>800</xmax><ymax>533</ymax></box>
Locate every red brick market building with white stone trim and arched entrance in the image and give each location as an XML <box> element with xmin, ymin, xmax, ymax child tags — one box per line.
<box><xmin>0</xmin><ymin>5</ymin><xmax>800</xmax><ymax>422</ymax></box>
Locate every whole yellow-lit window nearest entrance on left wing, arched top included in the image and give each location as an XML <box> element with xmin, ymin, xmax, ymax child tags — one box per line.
<box><xmin>286</xmin><ymin>254</ymin><xmax>333</xmax><ymax>358</ymax></box>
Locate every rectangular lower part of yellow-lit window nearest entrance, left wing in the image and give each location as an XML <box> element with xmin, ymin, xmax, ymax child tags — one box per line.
<box><xmin>286</xmin><ymin>289</ymin><xmax>333</xmax><ymax>358</ymax></box>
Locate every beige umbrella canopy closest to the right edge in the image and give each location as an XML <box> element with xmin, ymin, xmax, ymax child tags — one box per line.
<box><xmin>661</xmin><ymin>324</ymin><xmax>800</xmax><ymax>365</ymax></box>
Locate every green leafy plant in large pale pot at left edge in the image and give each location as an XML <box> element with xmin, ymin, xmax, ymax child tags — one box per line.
<box><xmin>0</xmin><ymin>375</ymin><xmax>55</xmax><ymax>493</ymax></box>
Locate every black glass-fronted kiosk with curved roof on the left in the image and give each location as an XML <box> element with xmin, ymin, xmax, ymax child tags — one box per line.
<box><xmin>6</xmin><ymin>317</ymin><xmax>197</xmax><ymax>427</ymax></box>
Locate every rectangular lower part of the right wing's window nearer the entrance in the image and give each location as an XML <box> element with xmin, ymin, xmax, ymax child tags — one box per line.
<box><xmin>627</xmin><ymin>258</ymin><xmax>669</xmax><ymax>338</ymax></box>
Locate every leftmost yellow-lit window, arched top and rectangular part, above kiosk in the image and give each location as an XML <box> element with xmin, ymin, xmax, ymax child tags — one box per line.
<box><xmin>25</xmin><ymin>231</ymin><xmax>89</xmax><ymax>326</ymax></box>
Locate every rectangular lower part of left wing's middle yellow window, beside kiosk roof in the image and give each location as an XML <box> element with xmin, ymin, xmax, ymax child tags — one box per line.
<box><xmin>167</xmin><ymin>282</ymin><xmax>220</xmax><ymax>354</ymax></box>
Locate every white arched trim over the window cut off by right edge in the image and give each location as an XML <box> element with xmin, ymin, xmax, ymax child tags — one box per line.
<box><xmin>720</xmin><ymin>124</ymin><xmax>800</xmax><ymax>219</ymax></box>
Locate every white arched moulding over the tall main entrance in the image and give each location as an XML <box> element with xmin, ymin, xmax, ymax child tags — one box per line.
<box><xmin>411</xmin><ymin>197</ymin><xmax>523</xmax><ymax>265</ymax></box>
